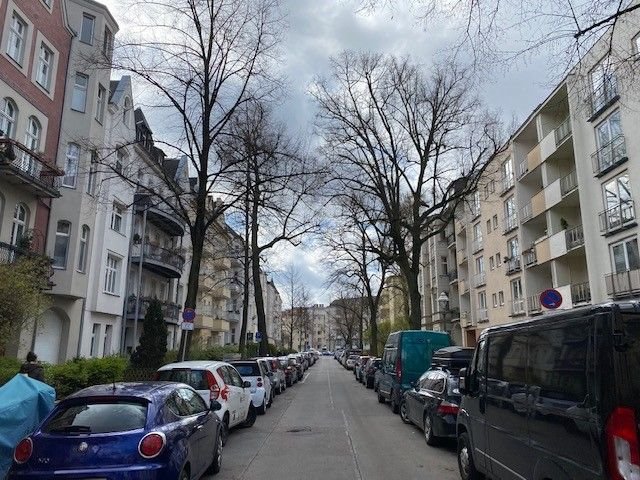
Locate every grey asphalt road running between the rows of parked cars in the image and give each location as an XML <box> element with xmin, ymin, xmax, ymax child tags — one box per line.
<box><xmin>205</xmin><ymin>357</ymin><xmax>460</xmax><ymax>480</ymax></box>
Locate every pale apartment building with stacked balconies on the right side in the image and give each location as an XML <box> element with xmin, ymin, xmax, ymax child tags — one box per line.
<box><xmin>422</xmin><ymin>12</ymin><xmax>640</xmax><ymax>345</ymax></box>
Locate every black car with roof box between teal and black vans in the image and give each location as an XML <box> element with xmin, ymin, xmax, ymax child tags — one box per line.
<box><xmin>400</xmin><ymin>347</ymin><xmax>473</xmax><ymax>445</ymax></box>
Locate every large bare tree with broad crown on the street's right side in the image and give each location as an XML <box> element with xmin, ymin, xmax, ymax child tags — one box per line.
<box><xmin>312</xmin><ymin>52</ymin><xmax>500</xmax><ymax>329</ymax></box>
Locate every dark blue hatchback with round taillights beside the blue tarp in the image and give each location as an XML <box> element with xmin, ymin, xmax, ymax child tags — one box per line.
<box><xmin>9</xmin><ymin>382</ymin><xmax>222</xmax><ymax>480</ymax></box>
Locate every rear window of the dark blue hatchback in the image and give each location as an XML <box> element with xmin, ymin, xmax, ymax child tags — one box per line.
<box><xmin>42</xmin><ymin>401</ymin><xmax>147</xmax><ymax>435</ymax></box>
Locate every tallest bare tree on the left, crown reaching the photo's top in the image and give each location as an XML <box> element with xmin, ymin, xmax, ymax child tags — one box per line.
<box><xmin>87</xmin><ymin>0</ymin><xmax>283</xmax><ymax>358</ymax></box>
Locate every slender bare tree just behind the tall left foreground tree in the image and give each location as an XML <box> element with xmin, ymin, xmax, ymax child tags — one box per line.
<box><xmin>219</xmin><ymin>102</ymin><xmax>322</xmax><ymax>355</ymax></box>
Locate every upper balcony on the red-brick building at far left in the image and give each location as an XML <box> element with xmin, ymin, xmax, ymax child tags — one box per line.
<box><xmin>0</xmin><ymin>138</ymin><xmax>63</xmax><ymax>198</ymax></box>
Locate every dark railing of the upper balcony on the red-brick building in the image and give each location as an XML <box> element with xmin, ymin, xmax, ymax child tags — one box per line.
<box><xmin>0</xmin><ymin>138</ymin><xmax>63</xmax><ymax>196</ymax></box>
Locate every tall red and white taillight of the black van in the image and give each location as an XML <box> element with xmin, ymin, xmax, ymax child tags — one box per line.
<box><xmin>606</xmin><ymin>407</ymin><xmax>640</xmax><ymax>480</ymax></box>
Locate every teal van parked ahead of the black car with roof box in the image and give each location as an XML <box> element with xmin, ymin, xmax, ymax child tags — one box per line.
<box><xmin>378</xmin><ymin>330</ymin><xmax>452</xmax><ymax>413</ymax></box>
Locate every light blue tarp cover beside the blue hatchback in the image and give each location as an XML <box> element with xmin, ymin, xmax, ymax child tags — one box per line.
<box><xmin>0</xmin><ymin>374</ymin><xmax>56</xmax><ymax>478</ymax></box>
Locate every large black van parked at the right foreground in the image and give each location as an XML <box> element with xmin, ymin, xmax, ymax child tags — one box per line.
<box><xmin>457</xmin><ymin>301</ymin><xmax>640</xmax><ymax>480</ymax></box>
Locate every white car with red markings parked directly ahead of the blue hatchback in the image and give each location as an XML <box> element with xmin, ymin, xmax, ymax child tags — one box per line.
<box><xmin>155</xmin><ymin>360</ymin><xmax>257</xmax><ymax>443</ymax></box>
